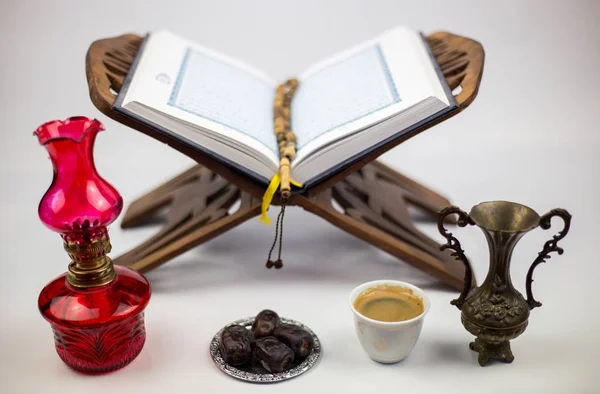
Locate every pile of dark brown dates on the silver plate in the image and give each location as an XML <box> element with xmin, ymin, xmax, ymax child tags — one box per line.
<box><xmin>219</xmin><ymin>309</ymin><xmax>313</xmax><ymax>373</ymax></box>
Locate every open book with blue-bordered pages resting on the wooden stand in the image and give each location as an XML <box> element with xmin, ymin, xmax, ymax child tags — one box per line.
<box><xmin>113</xmin><ymin>28</ymin><xmax>456</xmax><ymax>187</ymax></box>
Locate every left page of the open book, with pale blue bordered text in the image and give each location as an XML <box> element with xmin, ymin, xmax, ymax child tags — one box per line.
<box><xmin>122</xmin><ymin>32</ymin><xmax>279</xmax><ymax>163</ymax></box>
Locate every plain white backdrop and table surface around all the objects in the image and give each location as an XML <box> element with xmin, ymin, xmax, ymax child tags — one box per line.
<box><xmin>0</xmin><ymin>0</ymin><xmax>600</xmax><ymax>394</ymax></box>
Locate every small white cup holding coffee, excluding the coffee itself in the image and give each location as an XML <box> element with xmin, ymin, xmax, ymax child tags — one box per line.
<box><xmin>349</xmin><ymin>280</ymin><xmax>431</xmax><ymax>364</ymax></box>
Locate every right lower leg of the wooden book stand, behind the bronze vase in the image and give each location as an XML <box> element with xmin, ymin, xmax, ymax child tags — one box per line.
<box><xmin>298</xmin><ymin>162</ymin><xmax>472</xmax><ymax>289</ymax></box>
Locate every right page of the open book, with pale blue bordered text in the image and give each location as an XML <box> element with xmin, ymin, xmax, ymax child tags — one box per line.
<box><xmin>291</xmin><ymin>28</ymin><xmax>443</xmax><ymax>167</ymax></box>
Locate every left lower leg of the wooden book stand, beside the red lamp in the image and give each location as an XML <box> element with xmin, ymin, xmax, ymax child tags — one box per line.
<box><xmin>115</xmin><ymin>165</ymin><xmax>260</xmax><ymax>272</ymax></box>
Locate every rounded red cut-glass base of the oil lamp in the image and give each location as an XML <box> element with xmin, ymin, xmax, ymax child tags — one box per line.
<box><xmin>38</xmin><ymin>266</ymin><xmax>150</xmax><ymax>374</ymax></box>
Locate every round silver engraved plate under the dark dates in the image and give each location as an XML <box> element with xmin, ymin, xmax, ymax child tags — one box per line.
<box><xmin>210</xmin><ymin>317</ymin><xmax>321</xmax><ymax>383</ymax></box>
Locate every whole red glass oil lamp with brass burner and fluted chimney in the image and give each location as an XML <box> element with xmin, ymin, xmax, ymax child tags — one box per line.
<box><xmin>34</xmin><ymin>117</ymin><xmax>150</xmax><ymax>374</ymax></box>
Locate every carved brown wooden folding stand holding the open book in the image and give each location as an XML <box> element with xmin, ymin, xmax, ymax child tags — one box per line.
<box><xmin>86</xmin><ymin>32</ymin><xmax>484</xmax><ymax>289</ymax></box>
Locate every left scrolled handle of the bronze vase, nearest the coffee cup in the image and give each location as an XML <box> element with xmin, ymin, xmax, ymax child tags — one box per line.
<box><xmin>438</xmin><ymin>206</ymin><xmax>475</xmax><ymax>309</ymax></box>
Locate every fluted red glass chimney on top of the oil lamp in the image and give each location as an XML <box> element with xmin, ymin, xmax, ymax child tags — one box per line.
<box><xmin>34</xmin><ymin>117</ymin><xmax>123</xmax><ymax>234</ymax></box>
